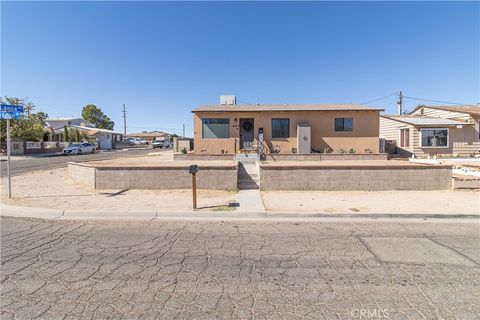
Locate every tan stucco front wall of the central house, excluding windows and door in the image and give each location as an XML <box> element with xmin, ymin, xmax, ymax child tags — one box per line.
<box><xmin>193</xmin><ymin>111</ymin><xmax>379</xmax><ymax>154</ymax></box>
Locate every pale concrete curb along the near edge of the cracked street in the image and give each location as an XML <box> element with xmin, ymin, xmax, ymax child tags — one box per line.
<box><xmin>0</xmin><ymin>203</ymin><xmax>480</xmax><ymax>222</ymax></box>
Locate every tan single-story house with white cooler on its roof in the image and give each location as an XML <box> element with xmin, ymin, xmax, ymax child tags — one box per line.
<box><xmin>192</xmin><ymin>96</ymin><xmax>383</xmax><ymax>154</ymax></box>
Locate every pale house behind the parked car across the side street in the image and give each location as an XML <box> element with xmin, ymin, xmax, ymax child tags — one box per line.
<box><xmin>45</xmin><ymin>118</ymin><xmax>122</xmax><ymax>150</ymax></box>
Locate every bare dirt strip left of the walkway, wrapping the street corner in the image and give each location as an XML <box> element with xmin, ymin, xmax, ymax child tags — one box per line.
<box><xmin>1</xmin><ymin>168</ymin><xmax>237</xmax><ymax>212</ymax></box>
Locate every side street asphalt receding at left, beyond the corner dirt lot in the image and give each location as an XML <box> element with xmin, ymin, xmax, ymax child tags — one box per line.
<box><xmin>0</xmin><ymin>148</ymin><xmax>154</xmax><ymax>177</ymax></box>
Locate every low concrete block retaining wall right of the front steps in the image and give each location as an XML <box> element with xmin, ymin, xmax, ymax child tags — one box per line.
<box><xmin>260</xmin><ymin>166</ymin><xmax>452</xmax><ymax>191</ymax></box>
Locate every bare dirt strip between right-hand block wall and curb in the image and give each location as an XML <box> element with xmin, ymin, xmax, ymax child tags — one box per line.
<box><xmin>262</xmin><ymin>191</ymin><xmax>480</xmax><ymax>214</ymax></box>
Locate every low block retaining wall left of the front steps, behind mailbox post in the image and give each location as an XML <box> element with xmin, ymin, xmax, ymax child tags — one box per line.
<box><xmin>68</xmin><ymin>163</ymin><xmax>237</xmax><ymax>190</ymax></box>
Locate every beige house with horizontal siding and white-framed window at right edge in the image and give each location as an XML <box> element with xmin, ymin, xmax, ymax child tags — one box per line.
<box><xmin>380</xmin><ymin>105</ymin><xmax>480</xmax><ymax>156</ymax></box>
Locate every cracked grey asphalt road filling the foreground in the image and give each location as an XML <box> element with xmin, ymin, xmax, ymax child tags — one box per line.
<box><xmin>1</xmin><ymin>218</ymin><xmax>480</xmax><ymax>319</ymax></box>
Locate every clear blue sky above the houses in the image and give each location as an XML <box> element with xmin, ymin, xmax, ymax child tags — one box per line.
<box><xmin>1</xmin><ymin>1</ymin><xmax>480</xmax><ymax>136</ymax></box>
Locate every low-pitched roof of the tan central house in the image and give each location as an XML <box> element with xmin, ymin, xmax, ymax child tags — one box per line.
<box><xmin>192</xmin><ymin>104</ymin><xmax>383</xmax><ymax>112</ymax></box>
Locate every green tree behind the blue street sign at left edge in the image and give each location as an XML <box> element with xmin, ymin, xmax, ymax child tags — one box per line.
<box><xmin>0</xmin><ymin>97</ymin><xmax>47</xmax><ymax>141</ymax></box>
